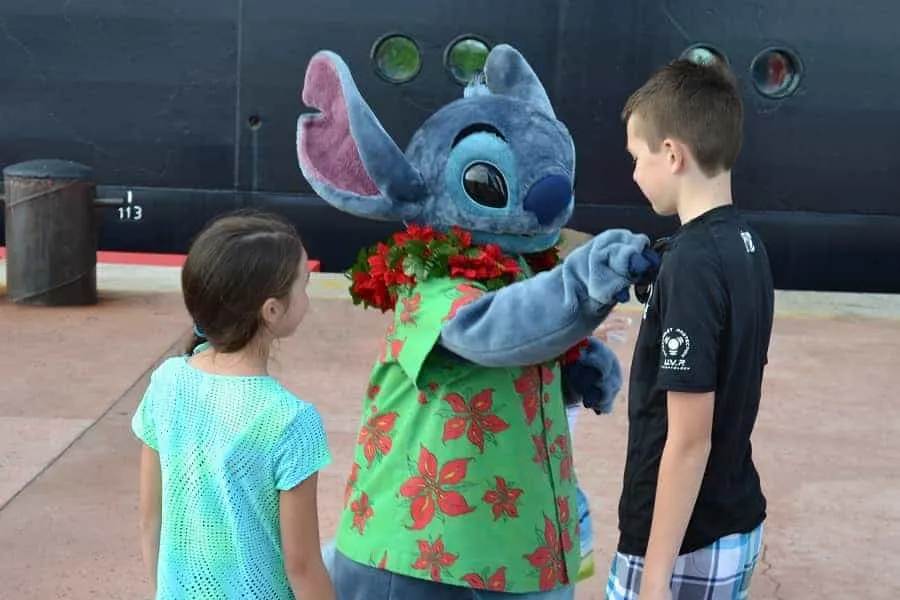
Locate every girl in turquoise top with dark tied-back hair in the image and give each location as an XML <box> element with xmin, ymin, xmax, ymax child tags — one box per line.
<box><xmin>132</xmin><ymin>214</ymin><xmax>334</xmax><ymax>600</ymax></box>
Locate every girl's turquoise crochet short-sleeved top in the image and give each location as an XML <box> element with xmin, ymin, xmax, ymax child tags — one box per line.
<box><xmin>132</xmin><ymin>349</ymin><xmax>331</xmax><ymax>600</ymax></box>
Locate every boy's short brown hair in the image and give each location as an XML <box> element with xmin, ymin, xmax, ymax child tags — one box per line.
<box><xmin>622</xmin><ymin>59</ymin><xmax>744</xmax><ymax>177</ymax></box>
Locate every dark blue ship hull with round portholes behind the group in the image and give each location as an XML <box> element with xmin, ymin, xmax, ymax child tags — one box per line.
<box><xmin>0</xmin><ymin>0</ymin><xmax>900</xmax><ymax>292</ymax></box>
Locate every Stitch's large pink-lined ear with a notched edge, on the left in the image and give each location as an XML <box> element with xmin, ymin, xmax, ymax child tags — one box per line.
<box><xmin>297</xmin><ymin>50</ymin><xmax>427</xmax><ymax>220</ymax></box>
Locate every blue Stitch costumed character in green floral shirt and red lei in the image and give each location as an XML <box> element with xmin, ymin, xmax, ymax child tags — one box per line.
<box><xmin>297</xmin><ymin>45</ymin><xmax>658</xmax><ymax>600</ymax></box>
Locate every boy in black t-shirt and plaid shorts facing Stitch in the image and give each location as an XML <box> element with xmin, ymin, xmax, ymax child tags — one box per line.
<box><xmin>606</xmin><ymin>60</ymin><xmax>774</xmax><ymax>600</ymax></box>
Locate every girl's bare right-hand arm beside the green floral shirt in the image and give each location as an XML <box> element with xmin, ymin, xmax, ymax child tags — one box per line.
<box><xmin>280</xmin><ymin>473</ymin><xmax>335</xmax><ymax>600</ymax></box>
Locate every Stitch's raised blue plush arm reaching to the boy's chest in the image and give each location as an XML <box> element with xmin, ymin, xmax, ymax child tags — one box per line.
<box><xmin>440</xmin><ymin>229</ymin><xmax>659</xmax><ymax>367</ymax></box>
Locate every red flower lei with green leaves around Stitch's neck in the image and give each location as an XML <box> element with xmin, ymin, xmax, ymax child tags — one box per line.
<box><xmin>347</xmin><ymin>224</ymin><xmax>588</xmax><ymax>364</ymax></box>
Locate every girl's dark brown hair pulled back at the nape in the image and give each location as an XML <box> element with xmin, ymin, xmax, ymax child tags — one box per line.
<box><xmin>181</xmin><ymin>211</ymin><xmax>306</xmax><ymax>355</ymax></box>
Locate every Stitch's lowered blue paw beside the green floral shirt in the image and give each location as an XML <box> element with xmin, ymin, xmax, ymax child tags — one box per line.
<box><xmin>562</xmin><ymin>338</ymin><xmax>622</xmax><ymax>415</ymax></box>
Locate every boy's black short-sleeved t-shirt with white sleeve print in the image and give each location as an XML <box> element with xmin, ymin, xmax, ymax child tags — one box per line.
<box><xmin>618</xmin><ymin>205</ymin><xmax>774</xmax><ymax>556</ymax></box>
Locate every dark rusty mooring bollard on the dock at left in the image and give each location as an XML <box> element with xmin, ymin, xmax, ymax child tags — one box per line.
<box><xmin>3</xmin><ymin>160</ymin><xmax>98</xmax><ymax>306</ymax></box>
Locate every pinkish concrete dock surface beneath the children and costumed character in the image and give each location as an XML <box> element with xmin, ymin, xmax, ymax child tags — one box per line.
<box><xmin>0</xmin><ymin>262</ymin><xmax>900</xmax><ymax>600</ymax></box>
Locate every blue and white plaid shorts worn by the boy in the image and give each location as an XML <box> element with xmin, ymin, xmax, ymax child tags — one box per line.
<box><xmin>606</xmin><ymin>523</ymin><xmax>763</xmax><ymax>600</ymax></box>
